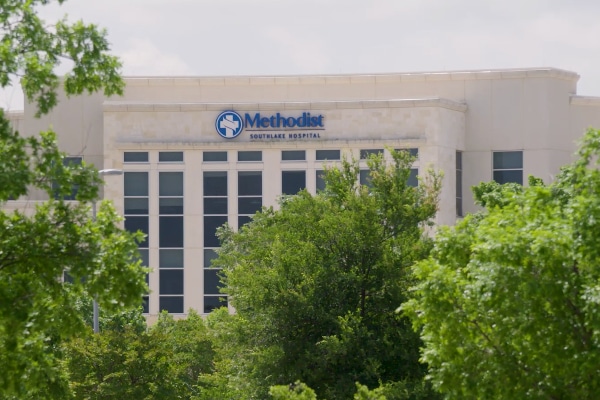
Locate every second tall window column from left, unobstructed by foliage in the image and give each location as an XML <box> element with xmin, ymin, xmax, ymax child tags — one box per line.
<box><xmin>158</xmin><ymin>171</ymin><xmax>184</xmax><ymax>314</ymax></box>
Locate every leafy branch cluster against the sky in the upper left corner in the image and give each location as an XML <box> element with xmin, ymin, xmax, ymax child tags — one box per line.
<box><xmin>0</xmin><ymin>0</ymin><xmax>124</xmax><ymax>114</ymax></box>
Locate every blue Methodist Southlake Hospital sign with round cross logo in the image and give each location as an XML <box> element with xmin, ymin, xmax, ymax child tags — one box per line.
<box><xmin>215</xmin><ymin>111</ymin><xmax>325</xmax><ymax>140</ymax></box>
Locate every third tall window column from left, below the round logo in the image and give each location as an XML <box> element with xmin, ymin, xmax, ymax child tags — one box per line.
<box><xmin>203</xmin><ymin>171</ymin><xmax>228</xmax><ymax>313</ymax></box>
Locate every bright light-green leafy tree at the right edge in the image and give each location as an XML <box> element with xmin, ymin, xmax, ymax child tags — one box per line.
<box><xmin>403</xmin><ymin>130</ymin><xmax>600</xmax><ymax>399</ymax></box>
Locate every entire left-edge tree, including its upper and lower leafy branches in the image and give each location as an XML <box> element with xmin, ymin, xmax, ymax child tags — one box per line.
<box><xmin>0</xmin><ymin>0</ymin><xmax>146</xmax><ymax>398</ymax></box>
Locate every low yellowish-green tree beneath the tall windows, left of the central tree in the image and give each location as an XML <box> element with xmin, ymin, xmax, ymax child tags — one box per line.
<box><xmin>66</xmin><ymin>310</ymin><xmax>213</xmax><ymax>399</ymax></box>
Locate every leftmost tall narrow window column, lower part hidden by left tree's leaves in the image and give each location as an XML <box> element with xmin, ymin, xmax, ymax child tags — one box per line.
<box><xmin>123</xmin><ymin>172</ymin><xmax>150</xmax><ymax>313</ymax></box>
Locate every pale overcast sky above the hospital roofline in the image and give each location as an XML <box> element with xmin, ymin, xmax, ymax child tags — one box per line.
<box><xmin>0</xmin><ymin>0</ymin><xmax>600</xmax><ymax>109</ymax></box>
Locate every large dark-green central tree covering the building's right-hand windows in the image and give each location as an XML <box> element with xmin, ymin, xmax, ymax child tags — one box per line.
<box><xmin>205</xmin><ymin>152</ymin><xmax>440</xmax><ymax>399</ymax></box>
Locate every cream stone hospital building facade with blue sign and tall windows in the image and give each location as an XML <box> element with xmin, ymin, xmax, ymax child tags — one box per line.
<box><xmin>7</xmin><ymin>68</ymin><xmax>600</xmax><ymax>316</ymax></box>
